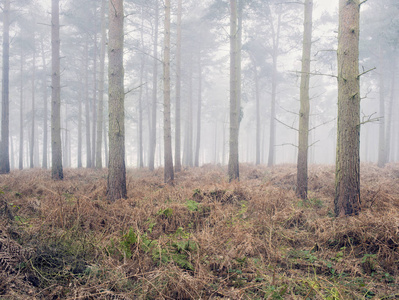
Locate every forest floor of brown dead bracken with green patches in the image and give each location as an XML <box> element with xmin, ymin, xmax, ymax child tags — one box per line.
<box><xmin>0</xmin><ymin>164</ymin><xmax>399</xmax><ymax>300</ymax></box>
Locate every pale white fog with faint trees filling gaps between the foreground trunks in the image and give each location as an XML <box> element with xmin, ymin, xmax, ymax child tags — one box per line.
<box><xmin>2</xmin><ymin>0</ymin><xmax>399</xmax><ymax>169</ymax></box>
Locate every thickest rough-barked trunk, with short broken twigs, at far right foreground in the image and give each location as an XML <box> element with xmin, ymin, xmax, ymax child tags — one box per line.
<box><xmin>334</xmin><ymin>0</ymin><xmax>360</xmax><ymax>216</ymax></box>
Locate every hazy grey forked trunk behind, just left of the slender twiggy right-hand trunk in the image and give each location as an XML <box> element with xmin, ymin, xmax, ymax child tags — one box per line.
<box><xmin>267</xmin><ymin>8</ymin><xmax>282</xmax><ymax>167</ymax></box>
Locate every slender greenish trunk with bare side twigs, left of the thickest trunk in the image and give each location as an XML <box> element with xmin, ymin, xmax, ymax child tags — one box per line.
<box><xmin>296</xmin><ymin>0</ymin><xmax>313</xmax><ymax>199</ymax></box>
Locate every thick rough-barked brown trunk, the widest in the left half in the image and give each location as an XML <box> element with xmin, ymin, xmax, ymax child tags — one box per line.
<box><xmin>107</xmin><ymin>0</ymin><xmax>126</xmax><ymax>201</ymax></box>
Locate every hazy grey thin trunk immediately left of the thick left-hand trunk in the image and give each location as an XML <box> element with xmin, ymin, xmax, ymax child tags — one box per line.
<box><xmin>96</xmin><ymin>0</ymin><xmax>107</xmax><ymax>169</ymax></box>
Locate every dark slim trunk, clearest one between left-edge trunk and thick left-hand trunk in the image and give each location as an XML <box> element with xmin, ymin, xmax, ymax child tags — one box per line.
<box><xmin>51</xmin><ymin>0</ymin><xmax>64</xmax><ymax>180</ymax></box>
